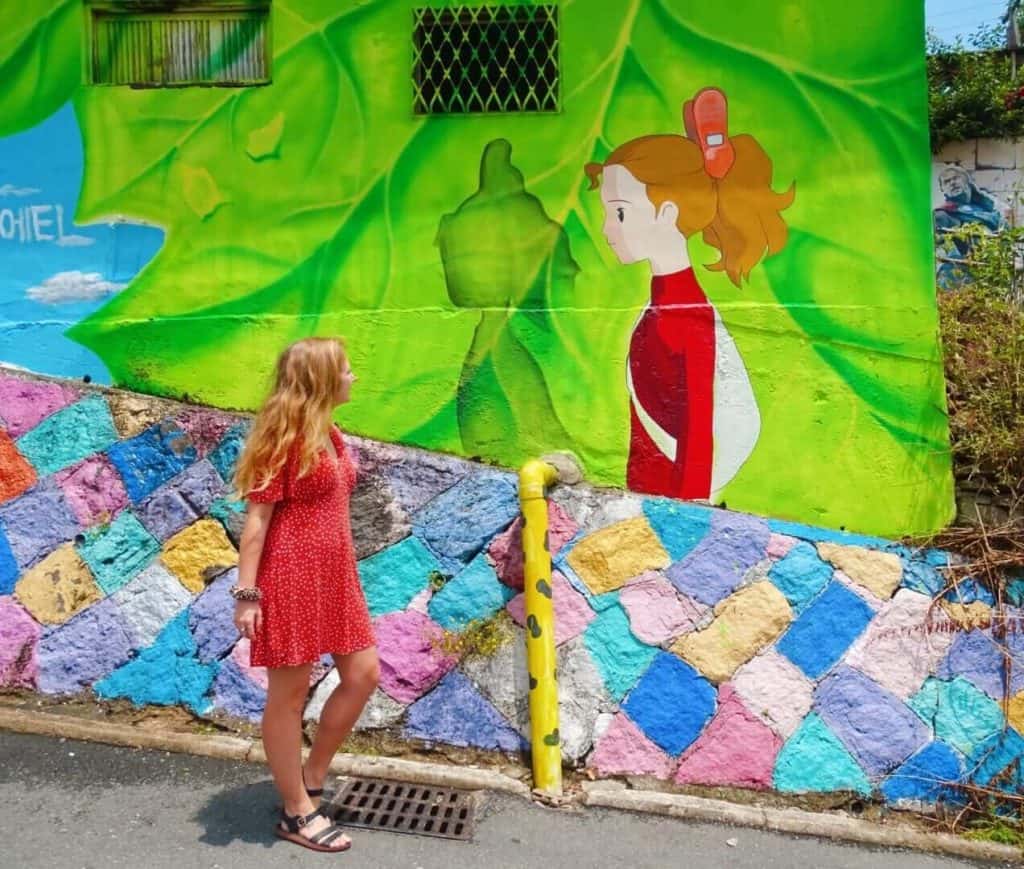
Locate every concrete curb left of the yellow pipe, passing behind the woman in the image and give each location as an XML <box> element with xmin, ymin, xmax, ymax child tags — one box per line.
<box><xmin>0</xmin><ymin>707</ymin><xmax>530</xmax><ymax>797</ymax></box>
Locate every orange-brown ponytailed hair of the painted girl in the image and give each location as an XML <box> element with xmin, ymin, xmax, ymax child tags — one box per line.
<box><xmin>584</xmin><ymin>88</ymin><xmax>796</xmax><ymax>287</ymax></box>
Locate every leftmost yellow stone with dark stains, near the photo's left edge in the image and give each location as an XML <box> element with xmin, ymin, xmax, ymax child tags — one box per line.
<box><xmin>14</xmin><ymin>544</ymin><xmax>103</xmax><ymax>624</ymax></box>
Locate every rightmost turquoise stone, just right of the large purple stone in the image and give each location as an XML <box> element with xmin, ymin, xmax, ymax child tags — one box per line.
<box><xmin>907</xmin><ymin>678</ymin><xmax>1004</xmax><ymax>755</ymax></box>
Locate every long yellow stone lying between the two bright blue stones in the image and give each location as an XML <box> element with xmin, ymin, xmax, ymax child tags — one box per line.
<box><xmin>672</xmin><ymin>581</ymin><xmax>793</xmax><ymax>682</ymax></box>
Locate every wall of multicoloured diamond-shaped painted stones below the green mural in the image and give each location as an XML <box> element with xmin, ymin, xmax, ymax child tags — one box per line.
<box><xmin>0</xmin><ymin>372</ymin><xmax>1024</xmax><ymax>802</ymax></box>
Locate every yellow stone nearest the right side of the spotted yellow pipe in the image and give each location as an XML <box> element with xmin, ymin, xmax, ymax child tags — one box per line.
<box><xmin>568</xmin><ymin>516</ymin><xmax>672</xmax><ymax>595</ymax></box>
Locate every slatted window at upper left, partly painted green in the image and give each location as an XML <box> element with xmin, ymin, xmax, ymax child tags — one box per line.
<box><xmin>86</xmin><ymin>0</ymin><xmax>271</xmax><ymax>87</ymax></box>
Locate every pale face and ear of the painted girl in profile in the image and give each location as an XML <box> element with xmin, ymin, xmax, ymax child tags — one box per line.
<box><xmin>601</xmin><ymin>166</ymin><xmax>686</xmax><ymax>265</ymax></box>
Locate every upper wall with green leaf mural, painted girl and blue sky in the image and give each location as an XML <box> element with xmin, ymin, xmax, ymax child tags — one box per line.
<box><xmin>0</xmin><ymin>0</ymin><xmax>953</xmax><ymax>536</ymax></box>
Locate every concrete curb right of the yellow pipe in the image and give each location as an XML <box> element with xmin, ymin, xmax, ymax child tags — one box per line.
<box><xmin>583</xmin><ymin>782</ymin><xmax>1022</xmax><ymax>863</ymax></box>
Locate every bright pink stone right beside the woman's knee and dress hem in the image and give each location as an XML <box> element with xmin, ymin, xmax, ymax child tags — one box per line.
<box><xmin>374</xmin><ymin>610</ymin><xmax>459</xmax><ymax>703</ymax></box>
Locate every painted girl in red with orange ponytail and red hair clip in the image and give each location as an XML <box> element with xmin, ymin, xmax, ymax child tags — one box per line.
<box><xmin>585</xmin><ymin>88</ymin><xmax>796</xmax><ymax>501</ymax></box>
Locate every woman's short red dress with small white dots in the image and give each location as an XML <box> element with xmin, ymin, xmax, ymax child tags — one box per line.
<box><xmin>249</xmin><ymin>426</ymin><xmax>376</xmax><ymax>667</ymax></box>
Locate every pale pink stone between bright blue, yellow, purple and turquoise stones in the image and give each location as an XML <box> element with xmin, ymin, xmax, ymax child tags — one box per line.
<box><xmin>732</xmin><ymin>649</ymin><xmax>814</xmax><ymax>739</ymax></box>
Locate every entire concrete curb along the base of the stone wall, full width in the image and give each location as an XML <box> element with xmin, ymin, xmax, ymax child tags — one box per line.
<box><xmin>0</xmin><ymin>706</ymin><xmax>1022</xmax><ymax>863</ymax></box>
